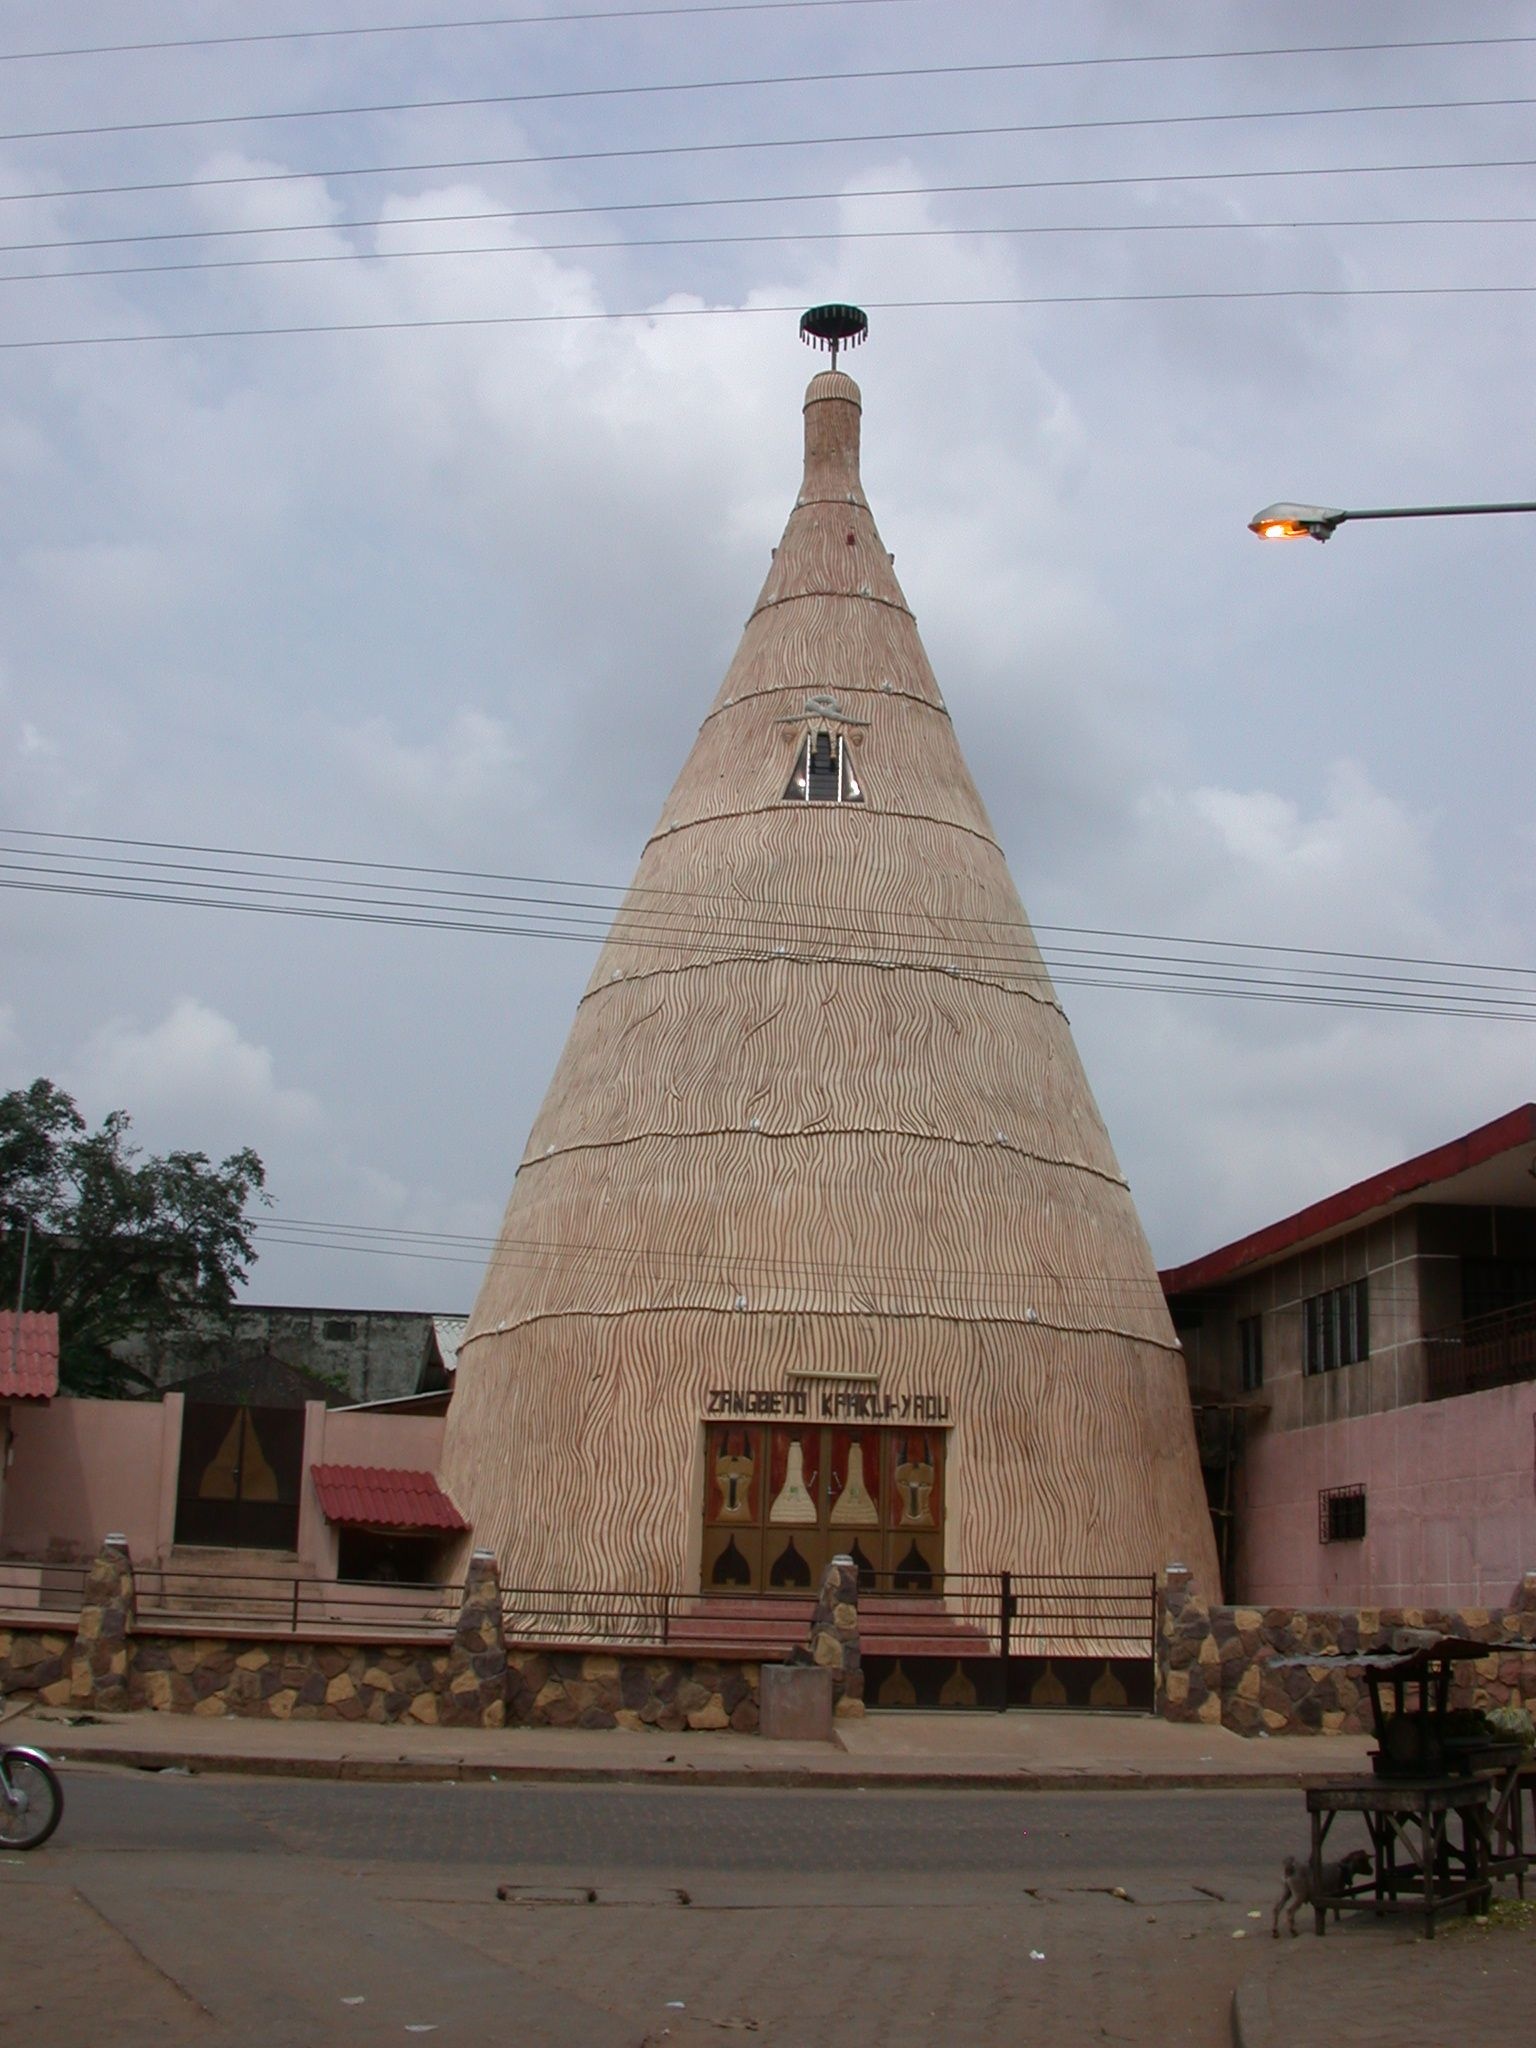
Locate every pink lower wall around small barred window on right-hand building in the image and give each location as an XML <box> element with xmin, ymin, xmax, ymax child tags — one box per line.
<box><xmin>1235</xmin><ymin>1382</ymin><xmax>1536</xmax><ymax>1608</ymax></box>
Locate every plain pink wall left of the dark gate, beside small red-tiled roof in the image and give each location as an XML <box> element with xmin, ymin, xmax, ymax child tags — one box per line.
<box><xmin>0</xmin><ymin>1395</ymin><xmax>182</xmax><ymax>1559</ymax></box>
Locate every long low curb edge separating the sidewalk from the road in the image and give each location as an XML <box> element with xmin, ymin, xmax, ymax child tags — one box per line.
<box><xmin>49</xmin><ymin>1745</ymin><xmax>1368</xmax><ymax>1792</ymax></box>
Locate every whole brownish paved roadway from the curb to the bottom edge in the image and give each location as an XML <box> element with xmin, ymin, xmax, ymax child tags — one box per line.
<box><xmin>0</xmin><ymin>1769</ymin><xmax>1327</xmax><ymax>2048</ymax></box>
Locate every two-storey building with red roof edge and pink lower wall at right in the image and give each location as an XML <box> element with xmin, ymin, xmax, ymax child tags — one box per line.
<box><xmin>1161</xmin><ymin>1102</ymin><xmax>1536</xmax><ymax>1606</ymax></box>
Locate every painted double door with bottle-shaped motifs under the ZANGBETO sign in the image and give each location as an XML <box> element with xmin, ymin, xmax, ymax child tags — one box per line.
<box><xmin>700</xmin><ymin>1423</ymin><xmax>944</xmax><ymax>1593</ymax></box>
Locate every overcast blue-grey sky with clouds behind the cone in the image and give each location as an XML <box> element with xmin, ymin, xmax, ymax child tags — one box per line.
<box><xmin>0</xmin><ymin>0</ymin><xmax>1536</xmax><ymax>1311</ymax></box>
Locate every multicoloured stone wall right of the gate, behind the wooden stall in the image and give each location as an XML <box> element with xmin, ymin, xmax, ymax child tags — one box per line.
<box><xmin>1157</xmin><ymin>1567</ymin><xmax>1536</xmax><ymax>1735</ymax></box>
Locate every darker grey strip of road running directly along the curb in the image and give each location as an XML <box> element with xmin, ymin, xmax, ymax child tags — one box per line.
<box><xmin>66</xmin><ymin>1772</ymin><xmax>1307</xmax><ymax>1890</ymax></box>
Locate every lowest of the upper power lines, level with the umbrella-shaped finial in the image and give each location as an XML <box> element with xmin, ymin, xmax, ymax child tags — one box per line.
<box><xmin>0</xmin><ymin>285</ymin><xmax>1536</xmax><ymax>350</ymax></box>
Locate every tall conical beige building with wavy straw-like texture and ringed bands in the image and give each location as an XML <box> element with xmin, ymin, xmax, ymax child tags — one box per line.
<box><xmin>442</xmin><ymin>335</ymin><xmax>1217</xmax><ymax>1595</ymax></box>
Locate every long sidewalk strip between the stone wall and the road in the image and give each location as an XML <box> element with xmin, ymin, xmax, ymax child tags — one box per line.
<box><xmin>4</xmin><ymin>1708</ymin><xmax>1370</xmax><ymax>1792</ymax></box>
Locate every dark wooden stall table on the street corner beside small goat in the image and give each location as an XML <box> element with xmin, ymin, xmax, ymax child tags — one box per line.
<box><xmin>1307</xmin><ymin>1774</ymin><xmax>1491</xmax><ymax>1939</ymax></box>
